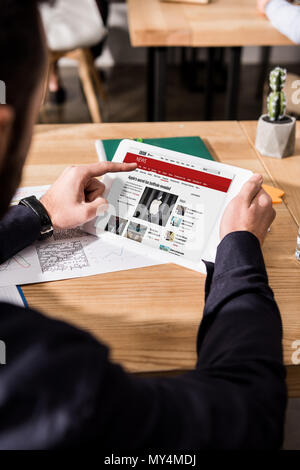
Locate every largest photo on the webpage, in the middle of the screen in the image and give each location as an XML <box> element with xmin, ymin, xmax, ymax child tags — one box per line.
<box><xmin>133</xmin><ymin>186</ymin><xmax>178</xmax><ymax>226</ymax></box>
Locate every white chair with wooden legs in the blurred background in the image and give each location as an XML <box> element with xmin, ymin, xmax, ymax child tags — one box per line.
<box><xmin>40</xmin><ymin>0</ymin><xmax>106</xmax><ymax>123</ymax></box>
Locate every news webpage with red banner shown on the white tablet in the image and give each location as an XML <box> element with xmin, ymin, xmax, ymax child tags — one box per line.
<box><xmin>97</xmin><ymin>147</ymin><xmax>234</xmax><ymax>262</ymax></box>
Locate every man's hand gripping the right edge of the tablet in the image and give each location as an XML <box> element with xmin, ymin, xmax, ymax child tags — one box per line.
<box><xmin>220</xmin><ymin>175</ymin><xmax>276</xmax><ymax>245</ymax></box>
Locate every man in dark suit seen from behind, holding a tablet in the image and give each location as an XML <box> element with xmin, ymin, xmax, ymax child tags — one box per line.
<box><xmin>0</xmin><ymin>0</ymin><xmax>286</xmax><ymax>450</ymax></box>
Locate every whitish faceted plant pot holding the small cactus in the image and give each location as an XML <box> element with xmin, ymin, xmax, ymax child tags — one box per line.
<box><xmin>255</xmin><ymin>114</ymin><xmax>296</xmax><ymax>158</ymax></box>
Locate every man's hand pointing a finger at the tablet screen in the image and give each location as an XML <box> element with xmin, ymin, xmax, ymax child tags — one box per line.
<box><xmin>41</xmin><ymin>162</ymin><xmax>137</xmax><ymax>229</ymax></box>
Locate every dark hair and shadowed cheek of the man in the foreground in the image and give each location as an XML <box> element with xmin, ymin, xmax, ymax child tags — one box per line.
<box><xmin>0</xmin><ymin>0</ymin><xmax>49</xmax><ymax>217</ymax></box>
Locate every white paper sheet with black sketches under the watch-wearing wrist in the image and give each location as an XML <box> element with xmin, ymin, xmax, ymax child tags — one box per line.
<box><xmin>0</xmin><ymin>186</ymin><xmax>162</xmax><ymax>286</ymax></box>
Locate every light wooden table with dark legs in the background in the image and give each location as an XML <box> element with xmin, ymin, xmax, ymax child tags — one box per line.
<box><xmin>127</xmin><ymin>0</ymin><xmax>293</xmax><ymax>121</ymax></box>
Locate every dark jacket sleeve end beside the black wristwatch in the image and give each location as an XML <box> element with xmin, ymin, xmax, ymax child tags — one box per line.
<box><xmin>0</xmin><ymin>206</ymin><xmax>41</xmax><ymax>264</ymax></box>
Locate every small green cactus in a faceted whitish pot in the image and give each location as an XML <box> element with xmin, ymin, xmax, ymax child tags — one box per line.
<box><xmin>255</xmin><ymin>67</ymin><xmax>296</xmax><ymax>158</ymax></box>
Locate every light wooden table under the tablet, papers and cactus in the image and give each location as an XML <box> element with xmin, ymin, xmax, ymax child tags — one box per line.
<box><xmin>22</xmin><ymin>121</ymin><xmax>300</xmax><ymax>396</ymax></box>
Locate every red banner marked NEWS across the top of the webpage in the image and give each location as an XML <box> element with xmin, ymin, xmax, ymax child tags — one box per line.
<box><xmin>124</xmin><ymin>153</ymin><xmax>232</xmax><ymax>193</ymax></box>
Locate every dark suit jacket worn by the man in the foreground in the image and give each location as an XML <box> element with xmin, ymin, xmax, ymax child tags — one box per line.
<box><xmin>0</xmin><ymin>206</ymin><xmax>286</xmax><ymax>450</ymax></box>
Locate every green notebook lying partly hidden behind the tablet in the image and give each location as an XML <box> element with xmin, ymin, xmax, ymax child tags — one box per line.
<box><xmin>102</xmin><ymin>136</ymin><xmax>213</xmax><ymax>161</ymax></box>
